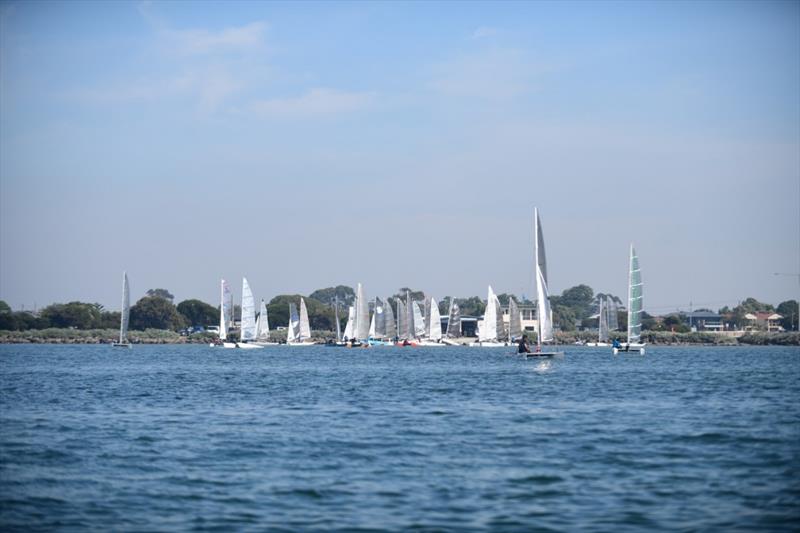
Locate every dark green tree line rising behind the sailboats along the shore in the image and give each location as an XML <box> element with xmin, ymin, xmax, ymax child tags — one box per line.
<box><xmin>0</xmin><ymin>284</ymin><xmax>800</xmax><ymax>332</ymax></box>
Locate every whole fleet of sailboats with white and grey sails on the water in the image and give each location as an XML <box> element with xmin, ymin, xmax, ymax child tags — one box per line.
<box><xmin>113</xmin><ymin>208</ymin><xmax>645</xmax><ymax>356</ymax></box>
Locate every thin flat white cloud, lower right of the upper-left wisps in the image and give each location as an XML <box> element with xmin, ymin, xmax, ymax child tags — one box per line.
<box><xmin>252</xmin><ymin>88</ymin><xmax>375</xmax><ymax>116</ymax></box>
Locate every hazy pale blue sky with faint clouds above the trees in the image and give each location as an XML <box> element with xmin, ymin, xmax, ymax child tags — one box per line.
<box><xmin>0</xmin><ymin>1</ymin><xmax>800</xmax><ymax>314</ymax></box>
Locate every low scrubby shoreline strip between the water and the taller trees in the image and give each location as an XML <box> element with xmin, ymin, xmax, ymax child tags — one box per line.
<box><xmin>0</xmin><ymin>328</ymin><xmax>800</xmax><ymax>346</ymax></box>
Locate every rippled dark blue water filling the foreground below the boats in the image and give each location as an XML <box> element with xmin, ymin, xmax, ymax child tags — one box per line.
<box><xmin>0</xmin><ymin>345</ymin><xmax>800</xmax><ymax>531</ymax></box>
